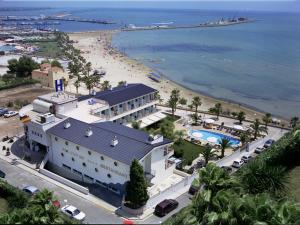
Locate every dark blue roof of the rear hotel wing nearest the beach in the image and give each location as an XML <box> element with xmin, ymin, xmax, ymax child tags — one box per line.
<box><xmin>78</xmin><ymin>84</ymin><xmax>157</xmax><ymax>106</ymax></box>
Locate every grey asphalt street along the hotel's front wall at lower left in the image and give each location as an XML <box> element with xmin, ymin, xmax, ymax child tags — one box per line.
<box><xmin>0</xmin><ymin>159</ymin><xmax>122</xmax><ymax>224</ymax></box>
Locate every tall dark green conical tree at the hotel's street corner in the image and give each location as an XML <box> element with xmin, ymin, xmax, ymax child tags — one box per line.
<box><xmin>125</xmin><ymin>159</ymin><xmax>149</xmax><ymax>209</ymax></box>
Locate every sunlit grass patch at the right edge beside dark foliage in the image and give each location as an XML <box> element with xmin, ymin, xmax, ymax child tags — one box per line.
<box><xmin>287</xmin><ymin>166</ymin><xmax>300</xmax><ymax>202</ymax></box>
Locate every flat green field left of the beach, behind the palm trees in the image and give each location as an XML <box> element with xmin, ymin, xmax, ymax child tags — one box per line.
<box><xmin>34</xmin><ymin>41</ymin><xmax>63</xmax><ymax>58</ymax></box>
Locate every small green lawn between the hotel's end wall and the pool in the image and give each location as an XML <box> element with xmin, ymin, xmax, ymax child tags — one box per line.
<box><xmin>173</xmin><ymin>140</ymin><xmax>203</xmax><ymax>165</ymax></box>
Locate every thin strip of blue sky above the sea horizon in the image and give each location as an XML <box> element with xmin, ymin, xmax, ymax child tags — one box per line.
<box><xmin>0</xmin><ymin>0</ymin><xmax>300</xmax><ymax>12</ymax></box>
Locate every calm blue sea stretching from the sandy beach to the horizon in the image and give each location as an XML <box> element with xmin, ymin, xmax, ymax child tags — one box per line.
<box><xmin>0</xmin><ymin>3</ymin><xmax>300</xmax><ymax>118</ymax></box>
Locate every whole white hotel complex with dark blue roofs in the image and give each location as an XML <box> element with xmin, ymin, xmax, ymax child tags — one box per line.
<box><xmin>20</xmin><ymin>84</ymin><xmax>175</xmax><ymax>195</ymax></box>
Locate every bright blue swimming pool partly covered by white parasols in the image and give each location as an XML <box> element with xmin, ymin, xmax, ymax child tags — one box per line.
<box><xmin>189</xmin><ymin>130</ymin><xmax>240</xmax><ymax>145</ymax></box>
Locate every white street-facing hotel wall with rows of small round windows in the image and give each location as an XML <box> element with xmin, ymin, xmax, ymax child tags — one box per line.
<box><xmin>49</xmin><ymin>135</ymin><xmax>130</xmax><ymax>184</ymax></box>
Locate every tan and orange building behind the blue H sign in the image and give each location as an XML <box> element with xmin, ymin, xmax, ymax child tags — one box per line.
<box><xmin>31</xmin><ymin>63</ymin><xmax>69</xmax><ymax>88</ymax></box>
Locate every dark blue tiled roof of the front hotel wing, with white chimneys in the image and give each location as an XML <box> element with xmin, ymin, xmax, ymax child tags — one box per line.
<box><xmin>47</xmin><ymin>118</ymin><xmax>171</xmax><ymax>165</ymax></box>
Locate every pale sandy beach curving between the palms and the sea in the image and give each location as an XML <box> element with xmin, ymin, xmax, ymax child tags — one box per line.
<box><xmin>69</xmin><ymin>31</ymin><xmax>274</xmax><ymax>119</ymax></box>
